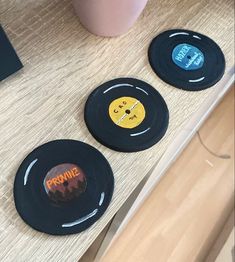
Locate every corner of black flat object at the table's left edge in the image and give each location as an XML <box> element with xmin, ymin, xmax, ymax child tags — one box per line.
<box><xmin>0</xmin><ymin>25</ymin><xmax>23</xmax><ymax>81</ymax></box>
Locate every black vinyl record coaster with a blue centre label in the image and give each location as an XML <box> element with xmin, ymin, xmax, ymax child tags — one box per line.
<box><xmin>148</xmin><ymin>29</ymin><xmax>225</xmax><ymax>91</ymax></box>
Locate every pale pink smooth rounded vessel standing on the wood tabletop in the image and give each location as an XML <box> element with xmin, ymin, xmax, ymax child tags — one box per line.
<box><xmin>73</xmin><ymin>0</ymin><xmax>148</xmax><ymax>36</ymax></box>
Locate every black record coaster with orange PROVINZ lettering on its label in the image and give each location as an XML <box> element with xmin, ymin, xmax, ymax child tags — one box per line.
<box><xmin>14</xmin><ymin>140</ymin><xmax>114</xmax><ymax>235</ymax></box>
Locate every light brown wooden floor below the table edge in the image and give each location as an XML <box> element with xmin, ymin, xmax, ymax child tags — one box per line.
<box><xmin>102</xmin><ymin>88</ymin><xmax>234</xmax><ymax>262</ymax></box>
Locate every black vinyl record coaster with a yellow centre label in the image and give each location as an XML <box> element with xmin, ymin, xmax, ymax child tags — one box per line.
<box><xmin>85</xmin><ymin>78</ymin><xmax>169</xmax><ymax>152</ymax></box>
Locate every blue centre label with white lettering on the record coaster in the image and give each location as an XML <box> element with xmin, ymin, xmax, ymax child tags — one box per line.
<box><xmin>172</xmin><ymin>43</ymin><xmax>204</xmax><ymax>71</ymax></box>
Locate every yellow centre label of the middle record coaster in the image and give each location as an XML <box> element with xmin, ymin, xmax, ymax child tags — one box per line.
<box><xmin>109</xmin><ymin>96</ymin><xmax>146</xmax><ymax>129</ymax></box>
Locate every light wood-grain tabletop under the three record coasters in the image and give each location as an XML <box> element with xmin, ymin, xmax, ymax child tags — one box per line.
<box><xmin>0</xmin><ymin>0</ymin><xmax>234</xmax><ymax>261</ymax></box>
